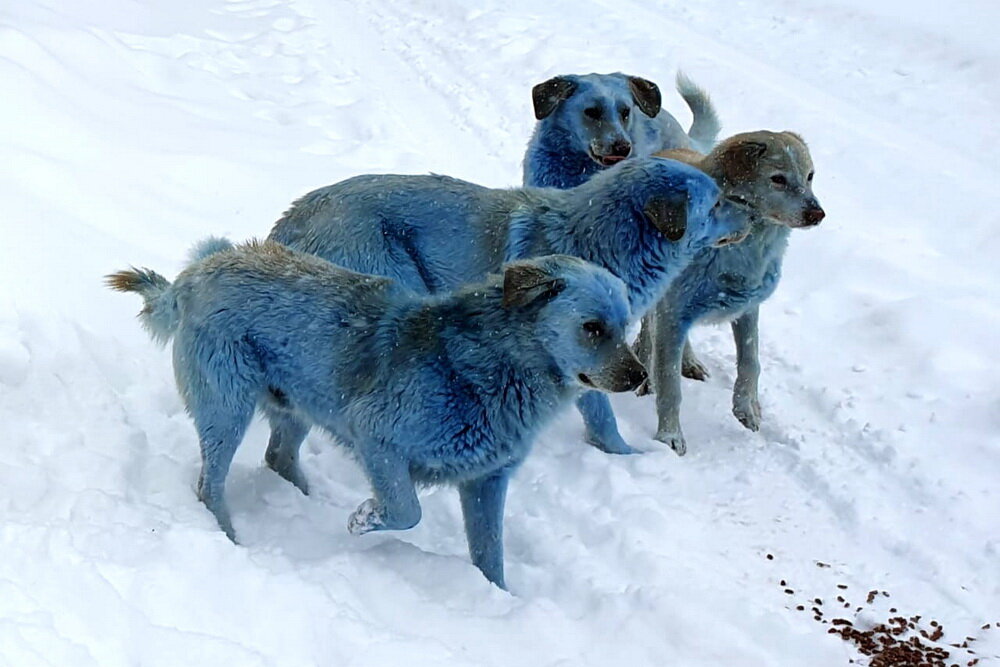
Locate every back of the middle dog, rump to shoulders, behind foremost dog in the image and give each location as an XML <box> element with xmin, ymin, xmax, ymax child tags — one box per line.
<box><xmin>268</xmin><ymin>174</ymin><xmax>518</xmax><ymax>294</ymax></box>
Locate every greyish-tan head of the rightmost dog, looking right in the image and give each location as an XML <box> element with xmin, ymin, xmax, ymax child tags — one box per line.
<box><xmin>702</xmin><ymin>130</ymin><xmax>826</xmax><ymax>228</ymax></box>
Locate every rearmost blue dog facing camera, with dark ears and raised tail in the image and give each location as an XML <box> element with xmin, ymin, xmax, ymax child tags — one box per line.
<box><xmin>524</xmin><ymin>73</ymin><xmax>719</xmax><ymax>189</ymax></box>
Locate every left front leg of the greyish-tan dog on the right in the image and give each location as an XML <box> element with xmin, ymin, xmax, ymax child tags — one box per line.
<box><xmin>652</xmin><ymin>299</ymin><xmax>688</xmax><ymax>456</ymax></box>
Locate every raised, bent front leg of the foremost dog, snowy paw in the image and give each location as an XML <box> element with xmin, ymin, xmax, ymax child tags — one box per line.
<box><xmin>347</xmin><ymin>443</ymin><xmax>420</xmax><ymax>535</ymax></box>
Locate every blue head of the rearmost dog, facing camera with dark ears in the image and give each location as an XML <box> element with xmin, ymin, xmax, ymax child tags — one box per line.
<box><xmin>531</xmin><ymin>73</ymin><xmax>661</xmax><ymax>167</ymax></box>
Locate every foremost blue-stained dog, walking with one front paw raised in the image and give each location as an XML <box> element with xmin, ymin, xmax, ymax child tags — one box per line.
<box><xmin>108</xmin><ymin>240</ymin><xmax>646</xmax><ymax>587</ymax></box>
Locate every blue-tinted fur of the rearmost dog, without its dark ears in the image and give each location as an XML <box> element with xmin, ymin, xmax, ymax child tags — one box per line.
<box><xmin>524</xmin><ymin>72</ymin><xmax>719</xmax><ymax>189</ymax></box>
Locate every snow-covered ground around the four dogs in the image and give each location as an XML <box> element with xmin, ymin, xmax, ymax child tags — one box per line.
<box><xmin>0</xmin><ymin>0</ymin><xmax>1000</xmax><ymax>667</ymax></box>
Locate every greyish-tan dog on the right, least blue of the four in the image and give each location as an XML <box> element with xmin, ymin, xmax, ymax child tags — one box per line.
<box><xmin>638</xmin><ymin>131</ymin><xmax>826</xmax><ymax>454</ymax></box>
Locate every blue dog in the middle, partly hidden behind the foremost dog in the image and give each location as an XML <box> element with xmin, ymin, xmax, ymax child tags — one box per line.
<box><xmin>269</xmin><ymin>157</ymin><xmax>749</xmax><ymax>454</ymax></box>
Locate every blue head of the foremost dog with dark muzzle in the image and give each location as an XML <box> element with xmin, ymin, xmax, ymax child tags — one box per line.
<box><xmin>503</xmin><ymin>255</ymin><xmax>646</xmax><ymax>392</ymax></box>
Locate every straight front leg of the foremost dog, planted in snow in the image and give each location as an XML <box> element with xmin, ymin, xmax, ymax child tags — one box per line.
<box><xmin>458</xmin><ymin>470</ymin><xmax>510</xmax><ymax>589</ymax></box>
